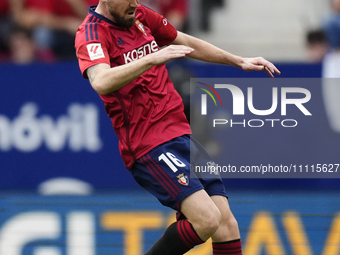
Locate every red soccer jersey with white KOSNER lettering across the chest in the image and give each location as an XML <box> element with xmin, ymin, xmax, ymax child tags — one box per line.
<box><xmin>75</xmin><ymin>5</ymin><xmax>190</xmax><ymax>168</ymax></box>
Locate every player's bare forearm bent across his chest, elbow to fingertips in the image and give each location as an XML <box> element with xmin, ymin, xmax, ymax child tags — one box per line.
<box><xmin>86</xmin><ymin>45</ymin><xmax>193</xmax><ymax>95</ymax></box>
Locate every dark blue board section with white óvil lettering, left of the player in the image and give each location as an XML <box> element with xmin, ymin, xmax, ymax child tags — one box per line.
<box><xmin>0</xmin><ymin>62</ymin><xmax>136</xmax><ymax>190</ymax></box>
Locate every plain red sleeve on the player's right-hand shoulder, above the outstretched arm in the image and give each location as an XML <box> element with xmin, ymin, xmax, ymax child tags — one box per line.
<box><xmin>141</xmin><ymin>5</ymin><xmax>177</xmax><ymax>47</ymax></box>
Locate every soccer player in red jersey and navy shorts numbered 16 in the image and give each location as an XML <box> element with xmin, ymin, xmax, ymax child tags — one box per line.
<box><xmin>75</xmin><ymin>0</ymin><xmax>280</xmax><ymax>255</ymax></box>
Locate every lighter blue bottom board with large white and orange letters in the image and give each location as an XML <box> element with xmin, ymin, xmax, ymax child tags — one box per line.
<box><xmin>0</xmin><ymin>191</ymin><xmax>340</xmax><ymax>255</ymax></box>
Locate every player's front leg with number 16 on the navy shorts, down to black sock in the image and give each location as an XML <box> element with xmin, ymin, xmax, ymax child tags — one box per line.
<box><xmin>131</xmin><ymin>137</ymin><xmax>221</xmax><ymax>255</ymax></box>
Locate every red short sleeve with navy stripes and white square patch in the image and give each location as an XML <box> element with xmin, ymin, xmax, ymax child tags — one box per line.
<box><xmin>75</xmin><ymin>23</ymin><xmax>110</xmax><ymax>79</ymax></box>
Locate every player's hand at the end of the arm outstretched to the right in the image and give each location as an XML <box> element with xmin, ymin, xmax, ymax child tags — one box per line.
<box><xmin>241</xmin><ymin>57</ymin><xmax>281</xmax><ymax>78</ymax></box>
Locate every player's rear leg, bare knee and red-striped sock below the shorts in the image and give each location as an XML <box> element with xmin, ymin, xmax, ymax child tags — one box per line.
<box><xmin>211</xmin><ymin>196</ymin><xmax>242</xmax><ymax>255</ymax></box>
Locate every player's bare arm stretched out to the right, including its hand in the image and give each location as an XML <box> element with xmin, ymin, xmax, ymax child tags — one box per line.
<box><xmin>173</xmin><ymin>32</ymin><xmax>281</xmax><ymax>77</ymax></box>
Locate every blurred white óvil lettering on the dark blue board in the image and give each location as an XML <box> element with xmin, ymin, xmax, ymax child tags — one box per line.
<box><xmin>0</xmin><ymin>102</ymin><xmax>102</xmax><ymax>152</ymax></box>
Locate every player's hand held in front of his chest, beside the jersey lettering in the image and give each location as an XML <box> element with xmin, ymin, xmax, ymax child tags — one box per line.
<box><xmin>148</xmin><ymin>45</ymin><xmax>194</xmax><ymax>65</ymax></box>
